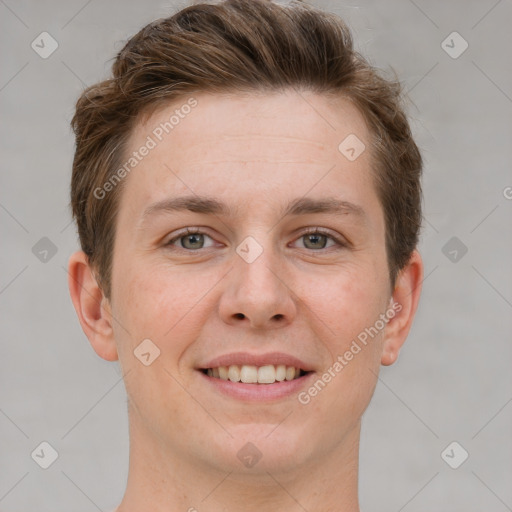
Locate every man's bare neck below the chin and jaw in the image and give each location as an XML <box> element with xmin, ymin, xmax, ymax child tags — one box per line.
<box><xmin>116</xmin><ymin>414</ymin><xmax>360</xmax><ymax>512</ymax></box>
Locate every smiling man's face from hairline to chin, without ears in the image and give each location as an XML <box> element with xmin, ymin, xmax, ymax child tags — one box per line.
<box><xmin>110</xmin><ymin>92</ymin><xmax>392</xmax><ymax>472</ymax></box>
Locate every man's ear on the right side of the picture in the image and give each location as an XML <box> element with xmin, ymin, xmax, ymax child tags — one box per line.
<box><xmin>381</xmin><ymin>250</ymin><xmax>423</xmax><ymax>366</ymax></box>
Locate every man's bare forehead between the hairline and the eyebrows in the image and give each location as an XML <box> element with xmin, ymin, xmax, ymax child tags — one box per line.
<box><xmin>118</xmin><ymin>91</ymin><xmax>373</xmax><ymax>224</ymax></box>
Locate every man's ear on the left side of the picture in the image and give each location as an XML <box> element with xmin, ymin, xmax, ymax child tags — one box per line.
<box><xmin>68</xmin><ymin>251</ymin><xmax>118</xmax><ymax>361</ymax></box>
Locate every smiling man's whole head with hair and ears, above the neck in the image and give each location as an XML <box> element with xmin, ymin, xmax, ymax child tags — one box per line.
<box><xmin>70</xmin><ymin>0</ymin><xmax>422</xmax><ymax>480</ymax></box>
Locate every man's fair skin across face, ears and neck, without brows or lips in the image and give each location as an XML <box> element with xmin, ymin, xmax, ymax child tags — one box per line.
<box><xmin>69</xmin><ymin>91</ymin><xmax>423</xmax><ymax>512</ymax></box>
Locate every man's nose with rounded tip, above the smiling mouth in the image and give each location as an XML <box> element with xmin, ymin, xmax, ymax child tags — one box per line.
<box><xmin>219</xmin><ymin>241</ymin><xmax>297</xmax><ymax>330</ymax></box>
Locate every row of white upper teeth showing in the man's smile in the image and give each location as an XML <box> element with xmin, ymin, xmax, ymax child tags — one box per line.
<box><xmin>206</xmin><ymin>364</ymin><xmax>300</xmax><ymax>384</ymax></box>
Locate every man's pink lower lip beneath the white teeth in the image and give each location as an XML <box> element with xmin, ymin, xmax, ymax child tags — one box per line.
<box><xmin>199</xmin><ymin>371</ymin><xmax>314</xmax><ymax>402</ymax></box>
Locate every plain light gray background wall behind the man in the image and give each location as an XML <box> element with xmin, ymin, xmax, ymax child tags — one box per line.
<box><xmin>0</xmin><ymin>0</ymin><xmax>512</xmax><ymax>512</ymax></box>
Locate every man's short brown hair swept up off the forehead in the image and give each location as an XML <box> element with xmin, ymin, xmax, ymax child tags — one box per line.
<box><xmin>71</xmin><ymin>0</ymin><xmax>422</xmax><ymax>298</ymax></box>
